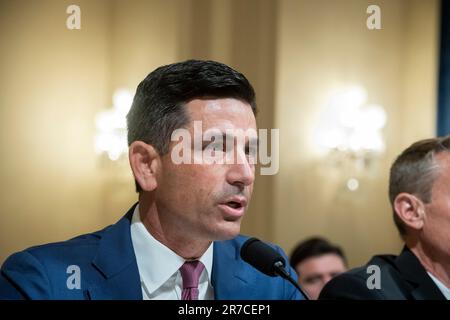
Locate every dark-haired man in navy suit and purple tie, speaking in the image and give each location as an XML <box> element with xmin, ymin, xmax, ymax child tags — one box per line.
<box><xmin>0</xmin><ymin>60</ymin><xmax>302</xmax><ymax>300</ymax></box>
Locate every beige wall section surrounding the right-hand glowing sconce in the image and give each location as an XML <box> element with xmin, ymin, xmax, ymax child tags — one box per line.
<box><xmin>274</xmin><ymin>0</ymin><xmax>438</xmax><ymax>265</ymax></box>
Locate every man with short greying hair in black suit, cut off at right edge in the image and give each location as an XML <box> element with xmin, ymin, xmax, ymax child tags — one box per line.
<box><xmin>320</xmin><ymin>136</ymin><xmax>450</xmax><ymax>300</ymax></box>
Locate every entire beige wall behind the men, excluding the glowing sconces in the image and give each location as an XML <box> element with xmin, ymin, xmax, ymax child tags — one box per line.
<box><xmin>0</xmin><ymin>0</ymin><xmax>438</xmax><ymax>264</ymax></box>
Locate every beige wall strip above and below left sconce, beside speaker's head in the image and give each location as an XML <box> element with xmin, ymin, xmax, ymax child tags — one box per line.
<box><xmin>97</xmin><ymin>0</ymin><xmax>180</xmax><ymax>223</ymax></box>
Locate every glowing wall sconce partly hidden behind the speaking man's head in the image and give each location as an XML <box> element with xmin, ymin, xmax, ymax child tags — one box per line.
<box><xmin>94</xmin><ymin>89</ymin><xmax>133</xmax><ymax>161</ymax></box>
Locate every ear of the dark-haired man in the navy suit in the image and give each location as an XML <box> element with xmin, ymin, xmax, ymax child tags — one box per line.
<box><xmin>128</xmin><ymin>141</ymin><xmax>160</xmax><ymax>191</ymax></box>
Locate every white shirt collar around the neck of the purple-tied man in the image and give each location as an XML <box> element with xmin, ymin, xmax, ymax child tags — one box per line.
<box><xmin>131</xmin><ymin>204</ymin><xmax>214</xmax><ymax>294</ymax></box>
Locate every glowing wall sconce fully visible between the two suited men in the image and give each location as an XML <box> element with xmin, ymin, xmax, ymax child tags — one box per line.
<box><xmin>316</xmin><ymin>86</ymin><xmax>386</xmax><ymax>191</ymax></box>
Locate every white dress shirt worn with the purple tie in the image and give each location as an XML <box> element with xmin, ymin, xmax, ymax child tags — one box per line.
<box><xmin>131</xmin><ymin>205</ymin><xmax>214</xmax><ymax>300</ymax></box>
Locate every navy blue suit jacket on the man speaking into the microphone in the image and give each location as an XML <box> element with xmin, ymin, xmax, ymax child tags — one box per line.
<box><xmin>0</xmin><ymin>206</ymin><xmax>303</xmax><ymax>300</ymax></box>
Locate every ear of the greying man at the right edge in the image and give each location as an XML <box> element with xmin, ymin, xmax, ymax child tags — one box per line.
<box><xmin>394</xmin><ymin>192</ymin><xmax>425</xmax><ymax>230</ymax></box>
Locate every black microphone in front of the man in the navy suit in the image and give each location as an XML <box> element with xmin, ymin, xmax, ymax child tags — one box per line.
<box><xmin>241</xmin><ymin>238</ymin><xmax>309</xmax><ymax>300</ymax></box>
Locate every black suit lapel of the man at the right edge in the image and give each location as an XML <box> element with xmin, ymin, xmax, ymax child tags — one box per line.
<box><xmin>395</xmin><ymin>247</ymin><xmax>445</xmax><ymax>300</ymax></box>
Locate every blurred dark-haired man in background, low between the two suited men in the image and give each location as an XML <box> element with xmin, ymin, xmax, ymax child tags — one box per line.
<box><xmin>290</xmin><ymin>238</ymin><xmax>347</xmax><ymax>300</ymax></box>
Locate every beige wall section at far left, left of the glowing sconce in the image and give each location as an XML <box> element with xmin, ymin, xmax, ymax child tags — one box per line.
<box><xmin>0</xmin><ymin>0</ymin><xmax>109</xmax><ymax>260</ymax></box>
